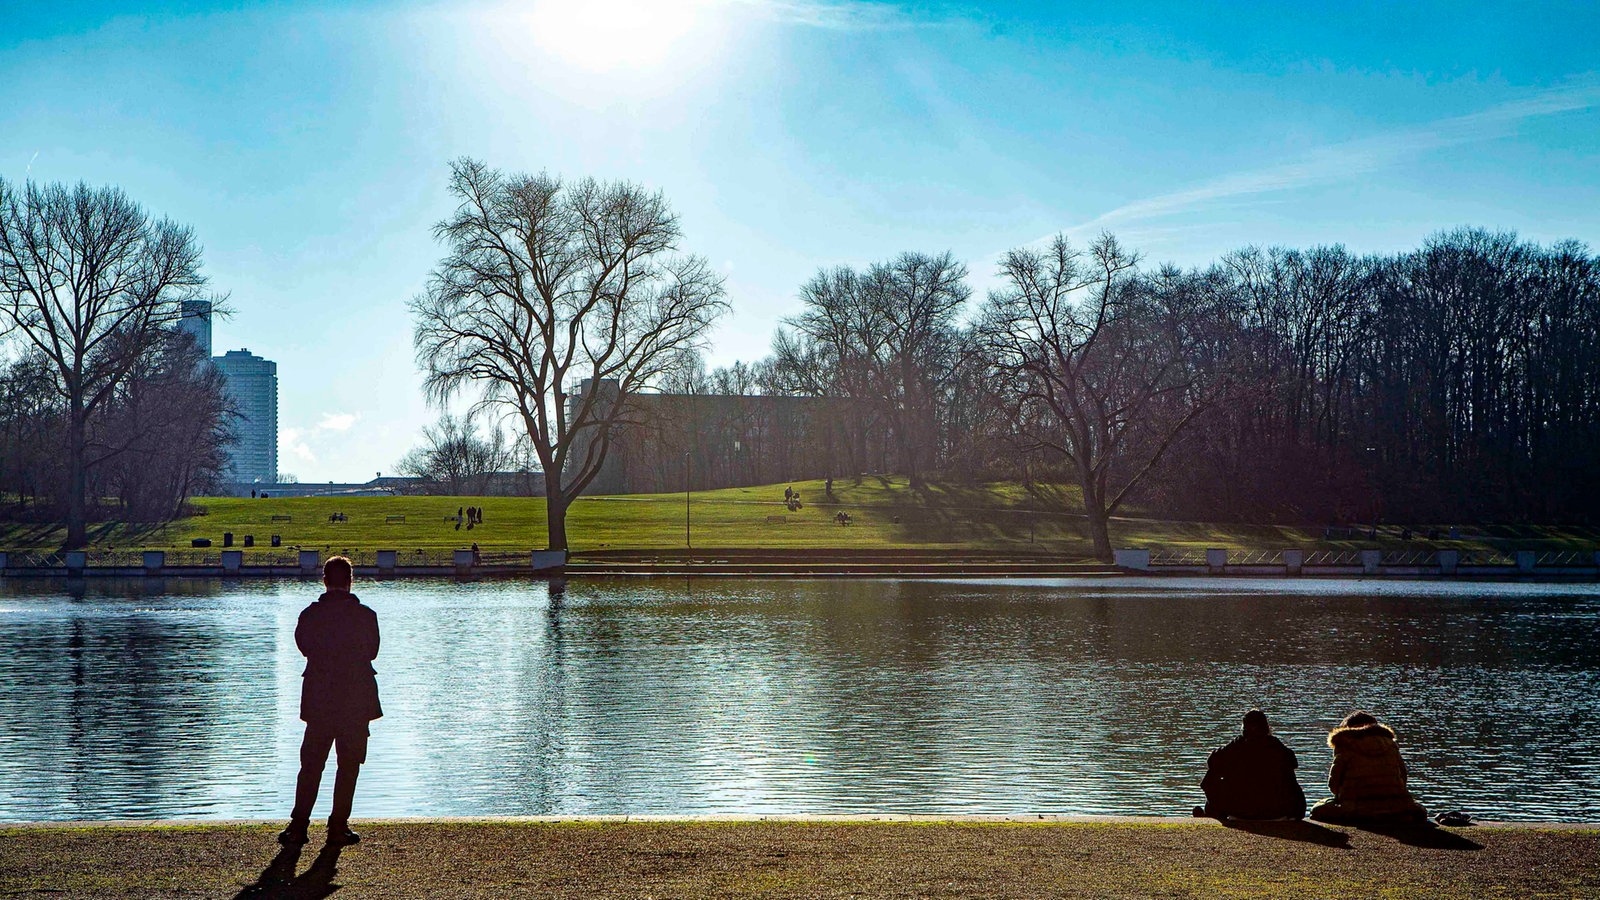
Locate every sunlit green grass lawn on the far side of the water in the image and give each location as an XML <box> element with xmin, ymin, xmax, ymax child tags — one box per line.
<box><xmin>0</xmin><ymin>477</ymin><xmax>1600</xmax><ymax>559</ymax></box>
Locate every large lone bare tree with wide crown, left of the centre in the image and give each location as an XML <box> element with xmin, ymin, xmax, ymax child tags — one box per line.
<box><xmin>411</xmin><ymin>159</ymin><xmax>726</xmax><ymax>549</ymax></box>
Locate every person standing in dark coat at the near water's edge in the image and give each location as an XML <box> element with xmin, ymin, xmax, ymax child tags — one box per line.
<box><xmin>278</xmin><ymin>556</ymin><xmax>384</xmax><ymax>846</ymax></box>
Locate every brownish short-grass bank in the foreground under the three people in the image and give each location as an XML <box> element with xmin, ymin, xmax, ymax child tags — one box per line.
<box><xmin>0</xmin><ymin>820</ymin><xmax>1600</xmax><ymax>900</ymax></box>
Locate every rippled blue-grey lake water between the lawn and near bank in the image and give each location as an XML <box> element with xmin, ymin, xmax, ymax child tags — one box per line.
<box><xmin>0</xmin><ymin>580</ymin><xmax>1600</xmax><ymax>822</ymax></box>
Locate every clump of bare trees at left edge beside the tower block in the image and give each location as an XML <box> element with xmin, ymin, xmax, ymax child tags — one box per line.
<box><xmin>0</xmin><ymin>179</ymin><xmax>229</xmax><ymax>538</ymax></box>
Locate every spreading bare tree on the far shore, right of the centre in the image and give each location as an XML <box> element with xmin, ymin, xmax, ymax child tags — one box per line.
<box><xmin>981</xmin><ymin>235</ymin><xmax>1211</xmax><ymax>562</ymax></box>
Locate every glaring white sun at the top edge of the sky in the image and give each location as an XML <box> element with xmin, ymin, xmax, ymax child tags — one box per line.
<box><xmin>528</xmin><ymin>0</ymin><xmax>717</xmax><ymax>72</ymax></box>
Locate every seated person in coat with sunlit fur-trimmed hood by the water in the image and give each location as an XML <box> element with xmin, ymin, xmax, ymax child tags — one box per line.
<box><xmin>1310</xmin><ymin>713</ymin><xmax>1427</xmax><ymax>825</ymax></box>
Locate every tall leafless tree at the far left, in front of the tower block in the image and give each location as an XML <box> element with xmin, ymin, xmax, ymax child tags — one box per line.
<box><xmin>0</xmin><ymin>181</ymin><xmax>217</xmax><ymax>548</ymax></box>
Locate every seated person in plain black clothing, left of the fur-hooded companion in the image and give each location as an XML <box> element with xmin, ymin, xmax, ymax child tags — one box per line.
<box><xmin>1195</xmin><ymin>709</ymin><xmax>1306</xmax><ymax>818</ymax></box>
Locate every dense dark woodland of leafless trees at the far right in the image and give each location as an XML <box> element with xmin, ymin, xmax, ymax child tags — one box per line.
<box><xmin>1158</xmin><ymin>229</ymin><xmax>1600</xmax><ymax>524</ymax></box>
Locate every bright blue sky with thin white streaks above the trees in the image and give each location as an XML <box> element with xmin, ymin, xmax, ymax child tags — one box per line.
<box><xmin>0</xmin><ymin>0</ymin><xmax>1600</xmax><ymax>482</ymax></box>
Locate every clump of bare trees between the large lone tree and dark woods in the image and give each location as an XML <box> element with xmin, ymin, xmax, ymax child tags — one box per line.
<box><xmin>757</xmin><ymin>235</ymin><xmax>1234</xmax><ymax>557</ymax></box>
